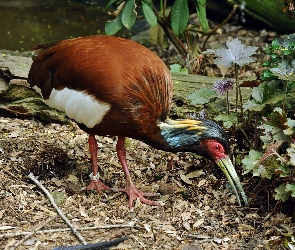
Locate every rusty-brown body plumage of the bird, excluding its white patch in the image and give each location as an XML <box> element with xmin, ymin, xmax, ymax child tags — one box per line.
<box><xmin>28</xmin><ymin>36</ymin><xmax>172</xmax><ymax>146</ymax></box>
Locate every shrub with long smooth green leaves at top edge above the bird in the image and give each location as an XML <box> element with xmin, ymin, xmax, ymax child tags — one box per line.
<box><xmin>105</xmin><ymin>0</ymin><xmax>209</xmax><ymax>56</ymax></box>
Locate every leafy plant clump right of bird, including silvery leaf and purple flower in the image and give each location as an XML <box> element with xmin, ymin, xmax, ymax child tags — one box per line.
<box><xmin>188</xmin><ymin>34</ymin><xmax>295</xmax><ymax>205</ymax></box>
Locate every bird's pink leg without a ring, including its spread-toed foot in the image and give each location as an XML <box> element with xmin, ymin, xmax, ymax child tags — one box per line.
<box><xmin>112</xmin><ymin>136</ymin><xmax>160</xmax><ymax>208</ymax></box>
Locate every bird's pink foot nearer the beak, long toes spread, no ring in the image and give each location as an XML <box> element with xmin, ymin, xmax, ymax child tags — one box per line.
<box><xmin>111</xmin><ymin>183</ymin><xmax>163</xmax><ymax>209</ymax></box>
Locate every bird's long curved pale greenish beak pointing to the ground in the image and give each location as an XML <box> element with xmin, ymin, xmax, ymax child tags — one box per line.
<box><xmin>215</xmin><ymin>157</ymin><xmax>248</xmax><ymax>206</ymax></box>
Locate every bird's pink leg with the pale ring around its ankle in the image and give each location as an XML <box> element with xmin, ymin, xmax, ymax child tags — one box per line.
<box><xmin>86</xmin><ymin>135</ymin><xmax>110</xmax><ymax>193</ymax></box>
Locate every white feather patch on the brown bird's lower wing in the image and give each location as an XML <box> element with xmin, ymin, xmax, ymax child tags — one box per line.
<box><xmin>34</xmin><ymin>86</ymin><xmax>111</xmax><ymax>128</ymax></box>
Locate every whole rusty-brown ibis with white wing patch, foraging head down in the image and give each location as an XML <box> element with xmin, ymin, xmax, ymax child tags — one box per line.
<box><xmin>28</xmin><ymin>36</ymin><xmax>248</xmax><ymax>208</ymax></box>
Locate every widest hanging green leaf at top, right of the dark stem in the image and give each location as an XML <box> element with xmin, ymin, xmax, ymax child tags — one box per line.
<box><xmin>171</xmin><ymin>0</ymin><xmax>189</xmax><ymax>36</ymax></box>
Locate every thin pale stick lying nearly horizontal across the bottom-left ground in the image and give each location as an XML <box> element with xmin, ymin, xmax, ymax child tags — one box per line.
<box><xmin>0</xmin><ymin>222</ymin><xmax>135</xmax><ymax>239</ymax></box>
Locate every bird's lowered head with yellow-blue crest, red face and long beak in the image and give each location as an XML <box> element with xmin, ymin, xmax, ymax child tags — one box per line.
<box><xmin>160</xmin><ymin>120</ymin><xmax>248</xmax><ymax>205</ymax></box>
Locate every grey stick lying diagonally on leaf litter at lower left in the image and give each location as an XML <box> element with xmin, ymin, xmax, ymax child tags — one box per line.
<box><xmin>28</xmin><ymin>173</ymin><xmax>87</xmax><ymax>245</ymax></box>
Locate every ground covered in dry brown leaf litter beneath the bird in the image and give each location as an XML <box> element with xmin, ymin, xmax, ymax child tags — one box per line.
<box><xmin>0</xmin><ymin>20</ymin><xmax>294</xmax><ymax>250</ymax></box>
